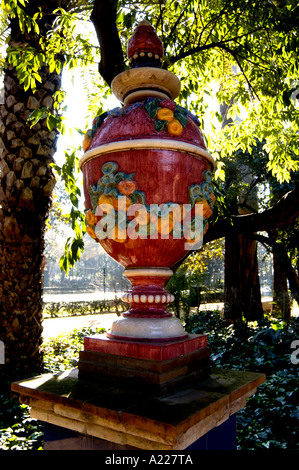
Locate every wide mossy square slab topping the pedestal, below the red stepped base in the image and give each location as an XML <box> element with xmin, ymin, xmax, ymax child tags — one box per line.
<box><xmin>12</xmin><ymin>369</ymin><xmax>265</xmax><ymax>450</ymax></box>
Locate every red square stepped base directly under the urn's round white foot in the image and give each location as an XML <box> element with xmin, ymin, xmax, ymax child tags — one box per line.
<box><xmin>78</xmin><ymin>335</ymin><xmax>210</xmax><ymax>393</ymax></box>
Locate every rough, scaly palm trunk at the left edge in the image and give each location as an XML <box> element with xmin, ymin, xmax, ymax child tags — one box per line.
<box><xmin>0</xmin><ymin>61</ymin><xmax>61</xmax><ymax>376</ymax></box>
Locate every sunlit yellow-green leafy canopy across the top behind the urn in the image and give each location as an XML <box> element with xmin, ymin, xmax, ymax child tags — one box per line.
<box><xmin>0</xmin><ymin>0</ymin><xmax>299</xmax><ymax>272</ymax></box>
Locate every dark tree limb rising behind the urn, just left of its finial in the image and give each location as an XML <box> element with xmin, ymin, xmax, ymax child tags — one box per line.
<box><xmin>90</xmin><ymin>0</ymin><xmax>125</xmax><ymax>86</ymax></box>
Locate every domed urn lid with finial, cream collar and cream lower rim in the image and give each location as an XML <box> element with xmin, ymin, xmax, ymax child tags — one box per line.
<box><xmin>80</xmin><ymin>21</ymin><xmax>214</xmax><ymax>170</ymax></box>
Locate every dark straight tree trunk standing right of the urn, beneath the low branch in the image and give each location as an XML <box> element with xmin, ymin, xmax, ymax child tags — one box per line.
<box><xmin>224</xmin><ymin>234</ymin><xmax>263</xmax><ymax>322</ymax></box>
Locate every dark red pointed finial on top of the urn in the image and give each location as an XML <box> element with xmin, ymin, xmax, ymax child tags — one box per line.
<box><xmin>128</xmin><ymin>20</ymin><xmax>163</xmax><ymax>68</ymax></box>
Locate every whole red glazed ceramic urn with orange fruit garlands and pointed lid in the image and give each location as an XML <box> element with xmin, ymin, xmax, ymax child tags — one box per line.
<box><xmin>80</xmin><ymin>22</ymin><xmax>215</xmax><ymax>341</ymax></box>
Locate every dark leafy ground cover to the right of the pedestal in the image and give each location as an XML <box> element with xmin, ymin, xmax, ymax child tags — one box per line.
<box><xmin>186</xmin><ymin>311</ymin><xmax>299</xmax><ymax>450</ymax></box>
